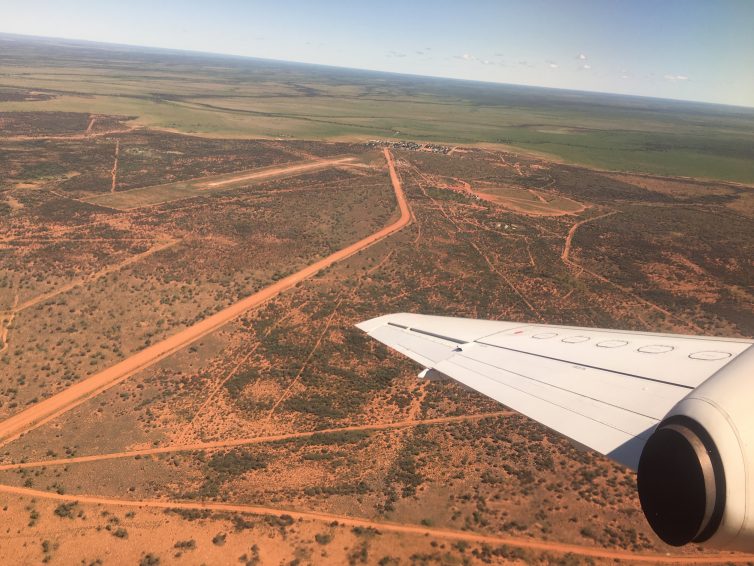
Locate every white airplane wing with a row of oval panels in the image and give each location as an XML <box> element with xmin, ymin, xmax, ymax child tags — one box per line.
<box><xmin>357</xmin><ymin>313</ymin><xmax>754</xmax><ymax>470</ymax></box>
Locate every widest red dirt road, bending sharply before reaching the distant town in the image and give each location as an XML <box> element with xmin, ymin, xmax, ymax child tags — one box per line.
<box><xmin>0</xmin><ymin>149</ymin><xmax>411</xmax><ymax>446</ymax></box>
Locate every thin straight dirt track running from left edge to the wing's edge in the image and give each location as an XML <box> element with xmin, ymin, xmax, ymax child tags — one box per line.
<box><xmin>0</xmin><ymin>411</ymin><xmax>516</xmax><ymax>471</ymax></box>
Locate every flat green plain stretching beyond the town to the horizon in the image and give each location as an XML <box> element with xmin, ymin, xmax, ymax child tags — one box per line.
<box><xmin>0</xmin><ymin>35</ymin><xmax>754</xmax><ymax>183</ymax></box>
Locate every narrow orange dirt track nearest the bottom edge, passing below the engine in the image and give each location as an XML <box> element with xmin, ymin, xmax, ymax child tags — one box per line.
<box><xmin>0</xmin><ymin>485</ymin><xmax>754</xmax><ymax>564</ymax></box>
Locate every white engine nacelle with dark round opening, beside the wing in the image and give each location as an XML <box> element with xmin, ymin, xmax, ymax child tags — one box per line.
<box><xmin>638</xmin><ymin>346</ymin><xmax>754</xmax><ymax>551</ymax></box>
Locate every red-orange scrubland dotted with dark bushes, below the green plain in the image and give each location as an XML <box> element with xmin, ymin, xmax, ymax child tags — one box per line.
<box><xmin>0</xmin><ymin>108</ymin><xmax>754</xmax><ymax>564</ymax></box>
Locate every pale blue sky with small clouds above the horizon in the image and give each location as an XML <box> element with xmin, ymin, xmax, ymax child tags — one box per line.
<box><xmin>0</xmin><ymin>0</ymin><xmax>754</xmax><ymax>106</ymax></box>
